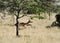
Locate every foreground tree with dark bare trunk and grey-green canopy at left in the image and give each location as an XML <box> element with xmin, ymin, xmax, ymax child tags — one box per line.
<box><xmin>0</xmin><ymin>0</ymin><xmax>24</xmax><ymax>36</ymax></box>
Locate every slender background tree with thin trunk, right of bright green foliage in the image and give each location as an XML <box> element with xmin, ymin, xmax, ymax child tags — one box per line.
<box><xmin>39</xmin><ymin>0</ymin><xmax>55</xmax><ymax>20</ymax></box>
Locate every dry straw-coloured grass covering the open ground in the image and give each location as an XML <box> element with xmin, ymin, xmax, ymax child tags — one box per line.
<box><xmin>0</xmin><ymin>15</ymin><xmax>60</xmax><ymax>43</ymax></box>
